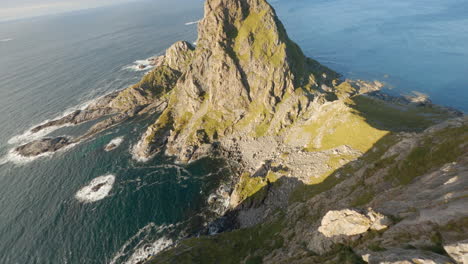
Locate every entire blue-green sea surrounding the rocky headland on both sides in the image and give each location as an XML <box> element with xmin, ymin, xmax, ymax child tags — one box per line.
<box><xmin>0</xmin><ymin>0</ymin><xmax>468</xmax><ymax>264</ymax></box>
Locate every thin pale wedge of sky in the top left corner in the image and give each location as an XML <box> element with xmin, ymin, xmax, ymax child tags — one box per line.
<box><xmin>0</xmin><ymin>0</ymin><xmax>136</xmax><ymax>21</ymax></box>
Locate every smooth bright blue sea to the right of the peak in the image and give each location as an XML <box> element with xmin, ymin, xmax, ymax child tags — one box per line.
<box><xmin>273</xmin><ymin>0</ymin><xmax>468</xmax><ymax>112</ymax></box>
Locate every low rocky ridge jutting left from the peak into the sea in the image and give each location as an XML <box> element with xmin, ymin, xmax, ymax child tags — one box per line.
<box><xmin>15</xmin><ymin>41</ymin><xmax>194</xmax><ymax>157</ymax></box>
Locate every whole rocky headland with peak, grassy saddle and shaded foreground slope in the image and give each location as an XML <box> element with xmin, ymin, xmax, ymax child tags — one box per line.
<box><xmin>12</xmin><ymin>0</ymin><xmax>468</xmax><ymax>264</ymax></box>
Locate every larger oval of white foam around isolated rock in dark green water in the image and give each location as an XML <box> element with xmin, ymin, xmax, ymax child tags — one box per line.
<box><xmin>75</xmin><ymin>175</ymin><xmax>115</xmax><ymax>203</ymax></box>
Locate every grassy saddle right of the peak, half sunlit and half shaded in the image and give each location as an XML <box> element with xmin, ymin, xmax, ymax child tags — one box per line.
<box><xmin>301</xmin><ymin>94</ymin><xmax>456</xmax><ymax>152</ymax></box>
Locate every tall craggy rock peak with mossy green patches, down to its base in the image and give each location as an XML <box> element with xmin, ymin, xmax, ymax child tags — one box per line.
<box><xmin>135</xmin><ymin>0</ymin><xmax>339</xmax><ymax>160</ymax></box>
